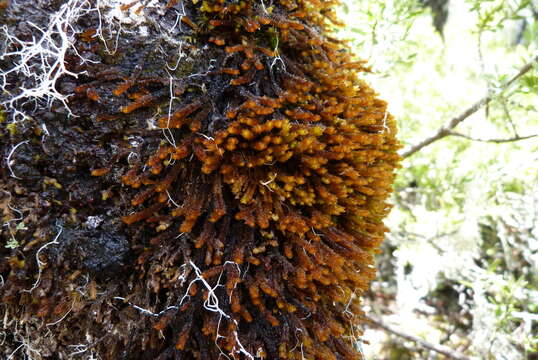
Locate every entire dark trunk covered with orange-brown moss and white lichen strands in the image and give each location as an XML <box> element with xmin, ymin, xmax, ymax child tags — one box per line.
<box><xmin>0</xmin><ymin>0</ymin><xmax>399</xmax><ymax>360</ymax></box>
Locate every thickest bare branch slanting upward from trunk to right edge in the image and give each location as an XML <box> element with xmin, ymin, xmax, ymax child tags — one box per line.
<box><xmin>401</xmin><ymin>54</ymin><xmax>538</xmax><ymax>158</ymax></box>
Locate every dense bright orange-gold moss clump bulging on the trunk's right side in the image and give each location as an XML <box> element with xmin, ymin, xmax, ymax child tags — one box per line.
<box><xmin>117</xmin><ymin>1</ymin><xmax>398</xmax><ymax>359</ymax></box>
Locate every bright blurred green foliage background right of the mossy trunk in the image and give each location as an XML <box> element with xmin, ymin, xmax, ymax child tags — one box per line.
<box><xmin>341</xmin><ymin>0</ymin><xmax>538</xmax><ymax>360</ymax></box>
